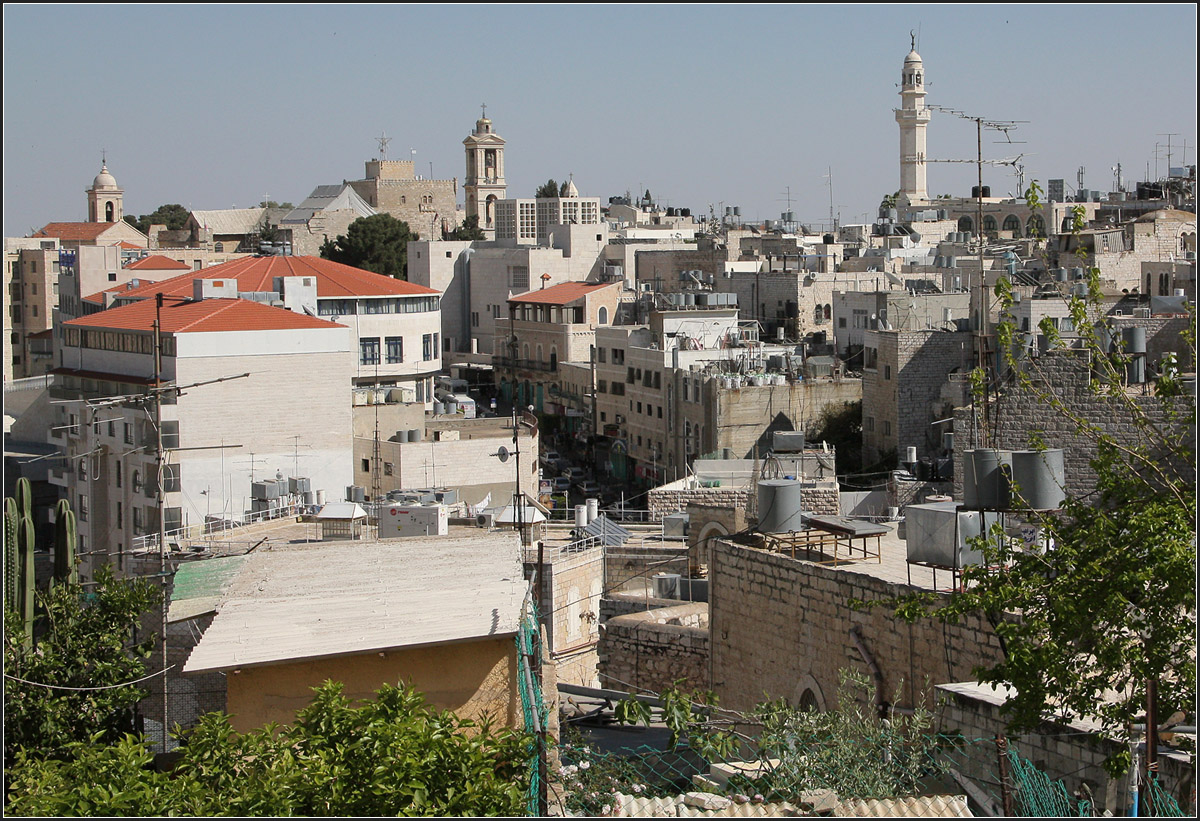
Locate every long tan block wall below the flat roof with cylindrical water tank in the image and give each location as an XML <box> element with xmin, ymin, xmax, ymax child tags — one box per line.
<box><xmin>708</xmin><ymin>540</ymin><xmax>1001</xmax><ymax>709</ymax></box>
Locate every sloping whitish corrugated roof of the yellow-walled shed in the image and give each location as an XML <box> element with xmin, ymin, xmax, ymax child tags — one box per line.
<box><xmin>184</xmin><ymin>532</ymin><xmax>527</xmax><ymax>672</ymax></box>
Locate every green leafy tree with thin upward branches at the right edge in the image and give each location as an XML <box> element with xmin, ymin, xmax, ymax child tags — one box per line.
<box><xmin>878</xmin><ymin>182</ymin><xmax>1196</xmax><ymax>773</ymax></box>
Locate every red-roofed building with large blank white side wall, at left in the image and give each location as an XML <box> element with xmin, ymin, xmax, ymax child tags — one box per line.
<box><xmin>49</xmin><ymin>294</ymin><xmax>353</xmax><ymax>576</ymax></box>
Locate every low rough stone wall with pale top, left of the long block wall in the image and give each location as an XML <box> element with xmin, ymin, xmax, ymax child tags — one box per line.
<box><xmin>599</xmin><ymin>604</ymin><xmax>709</xmax><ymax>693</ymax></box>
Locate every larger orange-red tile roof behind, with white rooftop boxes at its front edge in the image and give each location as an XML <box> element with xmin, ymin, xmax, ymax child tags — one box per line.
<box><xmin>110</xmin><ymin>257</ymin><xmax>440</xmax><ymax>299</ymax></box>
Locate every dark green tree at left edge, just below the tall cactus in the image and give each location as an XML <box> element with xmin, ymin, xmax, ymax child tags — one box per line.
<box><xmin>4</xmin><ymin>568</ymin><xmax>158</xmax><ymax>760</ymax></box>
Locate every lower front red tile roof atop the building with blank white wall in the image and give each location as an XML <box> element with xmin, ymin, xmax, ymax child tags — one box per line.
<box><xmin>62</xmin><ymin>296</ymin><xmax>343</xmax><ymax>334</ymax></box>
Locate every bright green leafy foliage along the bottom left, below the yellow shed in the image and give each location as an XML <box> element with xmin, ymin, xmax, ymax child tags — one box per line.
<box><xmin>5</xmin><ymin>682</ymin><xmax>529</xmax><ymax>816</ymax></box>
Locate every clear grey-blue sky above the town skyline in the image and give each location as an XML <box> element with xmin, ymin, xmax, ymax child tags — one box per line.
<box><xmin>4</xmin><ymin>4</ymin><xmax>1196</xmax><ymax>236</ymax></box>
